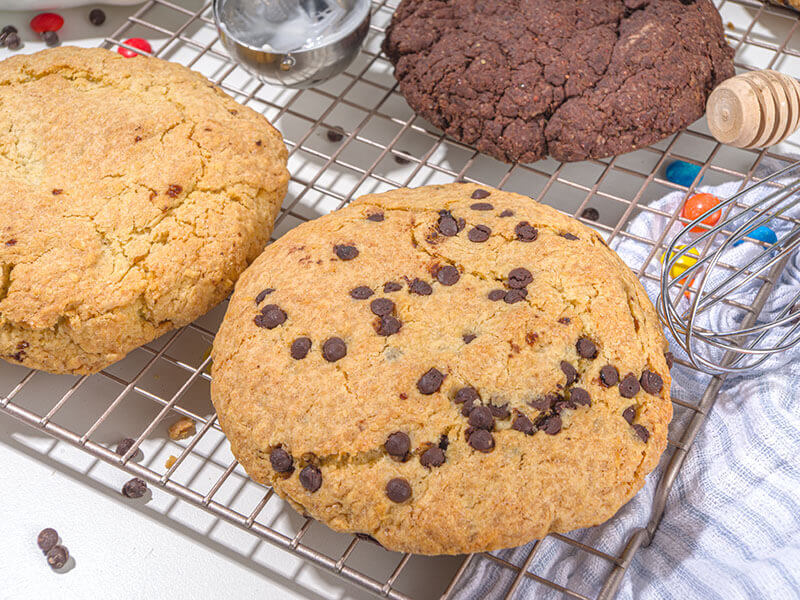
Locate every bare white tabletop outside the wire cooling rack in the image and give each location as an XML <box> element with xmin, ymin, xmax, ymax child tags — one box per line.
<box><xmin>0</xmin><ymin>0</ymin><xmax>458</xmax><ymax>600</ymax></box>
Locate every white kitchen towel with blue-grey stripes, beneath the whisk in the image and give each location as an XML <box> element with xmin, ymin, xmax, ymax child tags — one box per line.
<box><xmin>454</xmin><ymin>165</ymin><xmax>800</xmax><ymax>600</ymax></box>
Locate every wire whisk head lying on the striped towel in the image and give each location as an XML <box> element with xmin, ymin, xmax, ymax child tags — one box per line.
<box><xmin>656</xmin><ymin>161</ymin><xmax>800</xmax><ymax>374</ymax></box>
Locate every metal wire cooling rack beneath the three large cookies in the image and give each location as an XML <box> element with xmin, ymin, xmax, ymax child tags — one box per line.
<box><xmin>0</xmin><ymin>0</ymin><xmax>800</xmax><ymax>600</ymax></box>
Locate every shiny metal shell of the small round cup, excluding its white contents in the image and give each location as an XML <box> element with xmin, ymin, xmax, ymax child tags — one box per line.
<box><xmin>213</xmin><ymin>0</ymin><xmax>370</xmax><ymax>88</ymax></box>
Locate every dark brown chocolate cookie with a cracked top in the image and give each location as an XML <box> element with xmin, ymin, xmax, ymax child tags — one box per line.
<box><xmin>383</xmin><ymin>0</ymin><xmax>734</xmax><ymax>162</ymax></box>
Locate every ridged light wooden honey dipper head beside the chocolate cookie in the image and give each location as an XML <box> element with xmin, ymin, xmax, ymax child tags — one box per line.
<box><xmin>706</xmin><ymin>70</ymin><xmax>800</xmax><ymax>148</ymax></box>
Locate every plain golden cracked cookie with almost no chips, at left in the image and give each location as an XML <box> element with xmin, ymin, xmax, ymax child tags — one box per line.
<box><xmin>0</xmin><ymin>47</ymin><xmax>288</xmax><ymax>373</ymax></box>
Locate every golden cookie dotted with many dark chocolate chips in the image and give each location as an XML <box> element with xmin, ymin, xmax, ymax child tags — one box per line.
<box><xmin>211</xmin><ymin>184</ymin><xmax>672</xmax><ymax>554</ymax></box>
